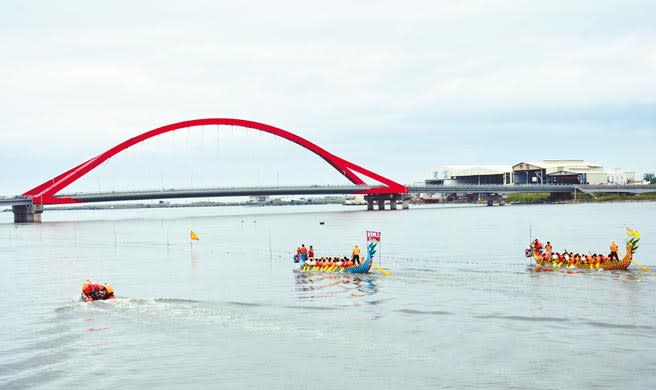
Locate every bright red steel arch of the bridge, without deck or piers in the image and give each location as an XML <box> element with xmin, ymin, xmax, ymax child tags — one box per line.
<box><xmin>23</xmin><ymin>118</ymin><xmax>408</xmax><ymax>204</ymax></box>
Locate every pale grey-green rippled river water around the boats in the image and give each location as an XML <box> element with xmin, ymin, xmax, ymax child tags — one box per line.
<box><xmin>0</xmin><ymin>203</ymin><xmax>656</xmax><ymax>389</ymax></box>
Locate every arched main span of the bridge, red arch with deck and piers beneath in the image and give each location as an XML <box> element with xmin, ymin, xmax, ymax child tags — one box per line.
<box><xmin>7</xmin><ymin>118</ymin><xmax>408</xmax><ymax>222</ymax></box>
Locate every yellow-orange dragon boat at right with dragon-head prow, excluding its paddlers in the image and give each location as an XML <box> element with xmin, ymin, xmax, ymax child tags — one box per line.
<box><xmin>525</xmin><ymin>228</ymin><xmax>640</xmax><ymax>271</ymax></box>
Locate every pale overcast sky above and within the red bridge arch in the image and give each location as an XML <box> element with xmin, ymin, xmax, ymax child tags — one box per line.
<box><xmin>0</xmin><ymin>0</ymin><xmax>656</xmax><ymax>195</ymax></box>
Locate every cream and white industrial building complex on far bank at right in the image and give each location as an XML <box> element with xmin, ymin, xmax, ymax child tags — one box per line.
<box><xmin>425</xmin><ymin>160</ymin><xmax>635</xmax><ymax>185</ymax></box>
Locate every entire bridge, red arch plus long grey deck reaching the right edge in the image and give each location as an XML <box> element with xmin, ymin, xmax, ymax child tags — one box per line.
<box><xmin>0</xmin><ymin>118</ymin><xmax>655</xmax><ymax>222</ymax></box>
